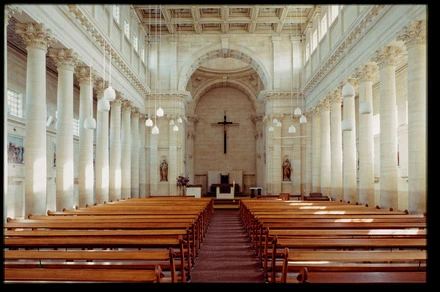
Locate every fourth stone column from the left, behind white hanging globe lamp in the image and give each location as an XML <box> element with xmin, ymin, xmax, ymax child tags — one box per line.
<box><xmin>95</xmin><ymin>81</ymin><xmax>110</xmax><ymax>204</ymax></box>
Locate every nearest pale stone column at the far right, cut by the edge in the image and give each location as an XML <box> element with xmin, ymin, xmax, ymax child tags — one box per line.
<box><xmin>401</xmin><ymin>20</ymin><xmax>428</xmax><ymax>214</ymax></box>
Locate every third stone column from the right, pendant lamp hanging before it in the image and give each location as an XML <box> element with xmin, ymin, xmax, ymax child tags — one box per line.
<box><xmin>358</xmin><ymin>63</ymin><xmax>377</xmax><ymax>206</ymax></box>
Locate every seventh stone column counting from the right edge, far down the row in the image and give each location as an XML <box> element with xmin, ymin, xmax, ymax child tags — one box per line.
<box><xmin>312</xmin><ymin>106</ymin><xmax>321</xmax><ymax>192</ymax></box>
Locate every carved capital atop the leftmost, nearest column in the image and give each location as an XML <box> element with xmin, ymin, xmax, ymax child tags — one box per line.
<box><xmin>15</xmin><ymin>22</ymin><xmax>56</xmax><ymax>50</ymax></box>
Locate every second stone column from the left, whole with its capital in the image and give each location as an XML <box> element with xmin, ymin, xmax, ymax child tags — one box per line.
<box><xmin>49</xmin><ymin>49</ymin><xmax>78</xmax><ymax>211</ymax></box>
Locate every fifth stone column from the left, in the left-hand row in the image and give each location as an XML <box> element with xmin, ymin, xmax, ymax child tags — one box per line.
<box><xmin>109</xmin><ymin>92</ymin><xmax>122</xmax><ymax>201</ymax></box>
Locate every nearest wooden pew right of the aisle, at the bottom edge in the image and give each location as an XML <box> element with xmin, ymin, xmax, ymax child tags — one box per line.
<box><xmin>297</xmin><ymin>267</ymin><xmax>426</xmax><ymax>284</ymax></box>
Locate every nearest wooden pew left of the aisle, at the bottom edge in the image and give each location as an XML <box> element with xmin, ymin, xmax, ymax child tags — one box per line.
<box><xmin>3</xmin><ymin>265</ymin><xmax>162</xmax><ymax>283</ymax></box>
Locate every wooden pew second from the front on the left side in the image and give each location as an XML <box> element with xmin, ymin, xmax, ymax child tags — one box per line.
<box><xmin>3</xmin><ymin>248</ymin><xmax>179</xmax><ymax>283</ymax></box>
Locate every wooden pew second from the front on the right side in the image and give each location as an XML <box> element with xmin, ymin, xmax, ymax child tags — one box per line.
<box><xmin>278</xmin><ymin>248</ymin><xmax>427</xmax><ymax>283</ymax></box>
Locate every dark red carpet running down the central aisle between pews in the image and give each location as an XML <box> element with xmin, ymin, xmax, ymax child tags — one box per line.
<box><xmin>191</xmin><ymin>209</ymin><xmax>265</xmax><ymax>283</ymax></box>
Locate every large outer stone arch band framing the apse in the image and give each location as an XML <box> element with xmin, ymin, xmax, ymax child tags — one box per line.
<box><xmin>178</xmin><ymin>43</ymin><xmax>272</xmax><ymax>91</ymax></box>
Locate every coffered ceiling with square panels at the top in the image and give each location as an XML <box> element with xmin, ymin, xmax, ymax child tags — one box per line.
<box><xmin>133</xmin><ymin>4</ymin><xmax>317</xmax><ymax>35</ymax></box>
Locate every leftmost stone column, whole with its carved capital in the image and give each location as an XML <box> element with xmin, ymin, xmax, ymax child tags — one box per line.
<box><xmin>16</xmin><ymin>23</ymin><xmax>55</xmax><ymax>215</ymax></box>
